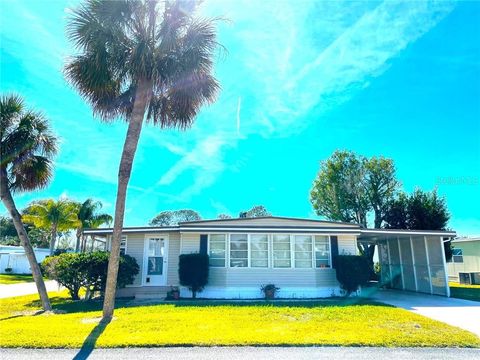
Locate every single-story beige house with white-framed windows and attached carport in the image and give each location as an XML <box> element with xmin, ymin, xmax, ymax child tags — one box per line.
<box><xmin>85</xmin><ymin>217</ymin><xmax>455</xmax><ymax>298</ymax></box>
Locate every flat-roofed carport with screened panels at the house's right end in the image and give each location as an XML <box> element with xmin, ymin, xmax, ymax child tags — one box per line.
<box><xmin>358</xmin><ymin>229</ymin><xmax>456</xmax><ymax>296</ymax></box>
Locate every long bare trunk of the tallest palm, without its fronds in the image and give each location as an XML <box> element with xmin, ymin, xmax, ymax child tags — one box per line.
<box><xmin>103</xmin><ymin>79</ymin><xmax>152</xmax><ymax>320</ymax></box>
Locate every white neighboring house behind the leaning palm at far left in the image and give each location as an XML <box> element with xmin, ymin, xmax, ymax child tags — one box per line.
<box><xmin>0</xmin><ymin>246</ymin><xmax>50</xmax><ymax>274</ymax></box>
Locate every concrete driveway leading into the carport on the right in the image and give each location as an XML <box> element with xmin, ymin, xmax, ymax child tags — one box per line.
<box><xmin>369</xmin><ymin>290</ymin><xmax>480</xmax><ymax>336</ymax></box>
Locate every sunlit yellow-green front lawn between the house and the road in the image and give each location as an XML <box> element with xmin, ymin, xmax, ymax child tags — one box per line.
<box><xmin>0</xmin><ymin>292</ymin><xmax>480</xmax><ymax>348</ymax></box>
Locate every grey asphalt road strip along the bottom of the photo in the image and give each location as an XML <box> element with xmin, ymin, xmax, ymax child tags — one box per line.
<box><xmin>0</xmin><ymin>347</ymin><xmax>480</xmax><ymax>360</ymax></box>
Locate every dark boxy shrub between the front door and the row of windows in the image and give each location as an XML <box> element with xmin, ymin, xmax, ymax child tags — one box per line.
<box><xmin>178</xmin><ymin>253</ymin><xmax>208</xmax><ymax>299</ymax></box>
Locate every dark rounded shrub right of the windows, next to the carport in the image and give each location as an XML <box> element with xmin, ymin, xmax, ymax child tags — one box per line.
<box><xmin>335</xmin><ymin>255</ymin><xmax>370</xmax><ymax>296</ymax></box>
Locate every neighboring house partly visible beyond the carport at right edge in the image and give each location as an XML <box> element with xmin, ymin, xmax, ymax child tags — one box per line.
<box><xmin>448</xmin><ymin>237</ymin><xmax>480</xmax><ymax>282</ymax></box>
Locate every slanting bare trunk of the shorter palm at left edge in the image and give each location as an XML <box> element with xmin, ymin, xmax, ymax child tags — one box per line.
<box><xmin>0</xmin><ymin>169</ymin><xmax>52</xmax><ymax>311</ymax></box>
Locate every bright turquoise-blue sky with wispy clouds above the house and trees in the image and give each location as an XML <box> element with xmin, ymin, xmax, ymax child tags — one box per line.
<box><xmin>0</xmin><ymin>0</ymin><xmax>480</xmax><ymax>234</ymax></box>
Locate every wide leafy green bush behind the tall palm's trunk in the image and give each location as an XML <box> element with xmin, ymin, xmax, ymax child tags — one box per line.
<box><xmin>41</xmin><ymin>251</ymin><xmax>139</xmax><ymax>300</ymax></box>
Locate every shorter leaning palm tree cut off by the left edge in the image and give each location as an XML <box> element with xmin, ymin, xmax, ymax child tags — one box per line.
<box><xmin>0</xmin><ymin>95</ymin><xmax>57</xmax><ymax>311</ymax></box>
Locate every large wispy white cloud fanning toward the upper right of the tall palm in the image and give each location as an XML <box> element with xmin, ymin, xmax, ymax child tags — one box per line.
<box><xmin>155</xmin><ymin>1</ymin><xmax>455</xmax><ymax>200</ymax></box>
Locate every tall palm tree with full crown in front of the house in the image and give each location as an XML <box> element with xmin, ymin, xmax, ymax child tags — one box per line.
<box><xmin>65</xmin><ymin>0</ymin><xmax>219</xmax><ymax>320</ymax></box>
